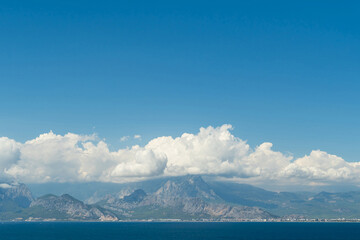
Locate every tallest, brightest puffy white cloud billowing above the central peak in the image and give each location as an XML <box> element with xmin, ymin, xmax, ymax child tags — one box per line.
<box><xmin>145</xmin><ymin>125</ymin><xmax>249</xmax><ymax>175</ymax></box>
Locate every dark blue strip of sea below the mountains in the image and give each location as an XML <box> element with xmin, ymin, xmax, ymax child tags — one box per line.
<box><xmin>0</xmin><ymin>222</ymin><xmax>360</xmax><ymax>240</ymax></box>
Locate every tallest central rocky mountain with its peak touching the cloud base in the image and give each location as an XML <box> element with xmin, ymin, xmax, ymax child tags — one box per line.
<box><xmin>98</xmin><ymin>176</ymin><xmax>274</xmax><ymax>220</ymax></box>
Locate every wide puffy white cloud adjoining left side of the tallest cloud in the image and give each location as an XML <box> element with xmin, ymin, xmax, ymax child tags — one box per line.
<box><xmin>3</xmin><ymin>132</ymin><xmax>166</xmax><ymax>182</ymax></box>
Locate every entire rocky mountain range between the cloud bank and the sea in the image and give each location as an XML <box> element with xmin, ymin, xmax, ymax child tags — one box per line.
<box><xmin>0</xmin><ymin>175</ymin><xmax>360</xmax><ymax>221</ymax></box>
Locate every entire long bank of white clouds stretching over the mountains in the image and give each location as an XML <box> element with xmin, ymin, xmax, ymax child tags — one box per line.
<box><xmin>0</xmin><ymin>125</ymin><xmax>360</xmax><ymax>184</ymax></box>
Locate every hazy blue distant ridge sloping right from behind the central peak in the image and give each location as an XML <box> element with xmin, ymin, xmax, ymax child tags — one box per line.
<box><xmin>209</xmin><ymin>182</ymin><xmax>360</xmax><ymax>218</ymax></box>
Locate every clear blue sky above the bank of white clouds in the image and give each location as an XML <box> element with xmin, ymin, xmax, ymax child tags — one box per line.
<box><xmin>0</xmin><ymin>0</ymin><xmax>360</xmax><ymax>161</ymax></box>
